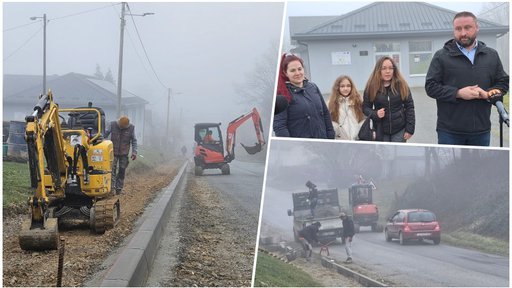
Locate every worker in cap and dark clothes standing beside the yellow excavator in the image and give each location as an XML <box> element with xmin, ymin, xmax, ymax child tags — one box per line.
<box><xmin>105</xmin><ymin>116</ymin><xmax>137</xmax><ymax>194</ymax></box>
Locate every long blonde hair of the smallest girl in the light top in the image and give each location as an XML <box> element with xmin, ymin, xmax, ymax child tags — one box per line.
<box><xmin>328</xmin><ymin>75</ymin><xmax>365</xmax><ymax>122</ymax></box>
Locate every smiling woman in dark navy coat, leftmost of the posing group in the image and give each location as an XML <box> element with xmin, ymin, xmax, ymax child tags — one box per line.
<box><xmin>273</xmin><ymin>54</ymin><xmax>335</xmax><ymax>139</ymax></box>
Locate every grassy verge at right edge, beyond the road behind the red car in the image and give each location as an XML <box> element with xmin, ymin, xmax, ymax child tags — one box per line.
<box><xmin>441</xmin><ymin>230</ymin><xmax>509</xmax><ymax>256</ymax></box>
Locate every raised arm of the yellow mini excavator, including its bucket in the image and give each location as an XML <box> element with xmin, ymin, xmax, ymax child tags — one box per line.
<box><xmin>19</xmin><ymin>92</ymin><xmax>67</xmax><ymax>250</ymax></box>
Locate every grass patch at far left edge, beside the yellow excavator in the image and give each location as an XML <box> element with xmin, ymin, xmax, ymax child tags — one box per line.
<box><xmin>2</xmin><ymin>161</ymin><xmax>30</xmax><ymax>208</ymax></box>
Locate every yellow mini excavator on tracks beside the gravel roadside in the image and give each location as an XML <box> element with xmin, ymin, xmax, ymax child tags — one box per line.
<box><xmin>19</xmin><ymin>91</ymin><xmax>120</xmax><ymax>250</ymax></box>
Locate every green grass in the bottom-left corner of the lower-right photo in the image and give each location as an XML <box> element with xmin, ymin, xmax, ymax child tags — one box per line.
<box><xmin>254</xmin><ymin>253</ymin><xmax>323</xmax><ymax>287</ymax></box>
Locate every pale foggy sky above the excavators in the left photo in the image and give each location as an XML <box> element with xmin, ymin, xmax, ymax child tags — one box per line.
<box><xmin>3</xmin><ymin>2</ymin><xmax>284</xmax><ymax>148</ymax></box>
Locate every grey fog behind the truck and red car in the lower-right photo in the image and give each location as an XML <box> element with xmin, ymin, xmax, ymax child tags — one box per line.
<box><xmin>261</xmin><ymin>140</ymin><xmax>509</xmax><ymax>239</ymax></box>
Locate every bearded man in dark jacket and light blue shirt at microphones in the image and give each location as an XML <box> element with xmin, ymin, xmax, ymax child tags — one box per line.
<box><xmin>425</xmin><ymin>12</ymin><xmax>509</xmax><ymax>146</ymax></box>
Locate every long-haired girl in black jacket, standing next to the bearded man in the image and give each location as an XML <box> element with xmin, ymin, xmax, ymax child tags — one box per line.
<box><xmin>363</xmin><ymin>56</ymin><xmax>415</xmax><ymax>142</ymax></box>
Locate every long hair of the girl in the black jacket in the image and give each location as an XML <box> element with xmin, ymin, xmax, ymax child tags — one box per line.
<box><xmin>365</xmin><ymin>56</ymin><xmax>409</xmax><ymax>102</ymax></box>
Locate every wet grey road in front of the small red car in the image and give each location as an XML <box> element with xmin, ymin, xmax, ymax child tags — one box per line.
<box><xmin>329</xmin><ymin>231</ymin><xmax>509</xmax><ymax>287</ymax></box>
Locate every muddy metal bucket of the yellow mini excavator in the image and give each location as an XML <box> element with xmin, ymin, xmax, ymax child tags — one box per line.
<box><xmin>19</xmin><ymin>218</ymin><xmax>59</xmax><ymax>251</ymax></box>
